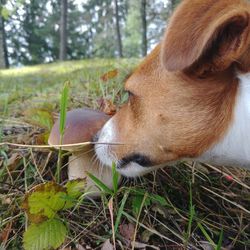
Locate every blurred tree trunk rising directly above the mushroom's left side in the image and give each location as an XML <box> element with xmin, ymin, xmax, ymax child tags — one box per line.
<box><xmin>59</xmin><ymin>0</ymin><xmax>68</xmax><ymax>61</ymax></box>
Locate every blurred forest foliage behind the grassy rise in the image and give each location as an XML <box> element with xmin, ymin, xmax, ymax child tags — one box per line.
<box><xmin>0</xmin><ymin>0</ymin><xmax>179</xmax><ymax>68</ymax></box>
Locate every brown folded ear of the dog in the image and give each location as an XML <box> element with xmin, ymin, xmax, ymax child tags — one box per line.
<box><xmin>161</xmin><ymin>0</ymin><xmax>250</xmax><ymax>75</ymax></box>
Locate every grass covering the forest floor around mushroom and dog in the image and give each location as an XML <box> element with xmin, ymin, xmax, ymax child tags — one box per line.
<box><xmin>0</xmin><ymin>59</ymin><xmax>250</xmax><ymax>250</ymax></box>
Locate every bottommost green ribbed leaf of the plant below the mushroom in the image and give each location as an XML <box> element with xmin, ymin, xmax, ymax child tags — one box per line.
<box><xmin>23</xmin><ymin>219</ymin><xmax>67</xmax><ymax>250</ymax></box>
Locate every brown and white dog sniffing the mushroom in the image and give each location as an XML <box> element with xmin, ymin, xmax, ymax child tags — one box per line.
<box><xmin>95</xmin><ymin>0</ymin><xmax>250</xmax><ymax>176</ymax></box>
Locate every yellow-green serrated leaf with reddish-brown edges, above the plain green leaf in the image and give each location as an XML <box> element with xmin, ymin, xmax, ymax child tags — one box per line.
<box><xmin>23</xmin><ymin>182</ymin><xmax>67</xmax><ymax>223</ymax></box>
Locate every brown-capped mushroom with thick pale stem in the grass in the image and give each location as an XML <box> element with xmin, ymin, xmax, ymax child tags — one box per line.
<box><xmin>48</xmin><ymin>109</ymin><xmax>120</xmax><ymax>197</ymax></box>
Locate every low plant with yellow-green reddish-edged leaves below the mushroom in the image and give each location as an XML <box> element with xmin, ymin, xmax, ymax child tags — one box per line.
<box><xmin>22</xmin><ymin>179</ymin><xmax>85</xmax><ymax>250</ymax></box>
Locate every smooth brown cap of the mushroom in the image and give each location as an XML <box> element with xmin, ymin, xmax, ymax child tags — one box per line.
<box><xmin>48</xmin><ymin>108</ymin><xmax>110</xmax><ymax>151</ymax></box>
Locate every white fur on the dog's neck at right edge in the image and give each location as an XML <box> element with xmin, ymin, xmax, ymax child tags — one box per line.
<box><xmin>198</xmin><ymin>73</ymin><xmax>250</xmax><ymax>169</ymax></box>
